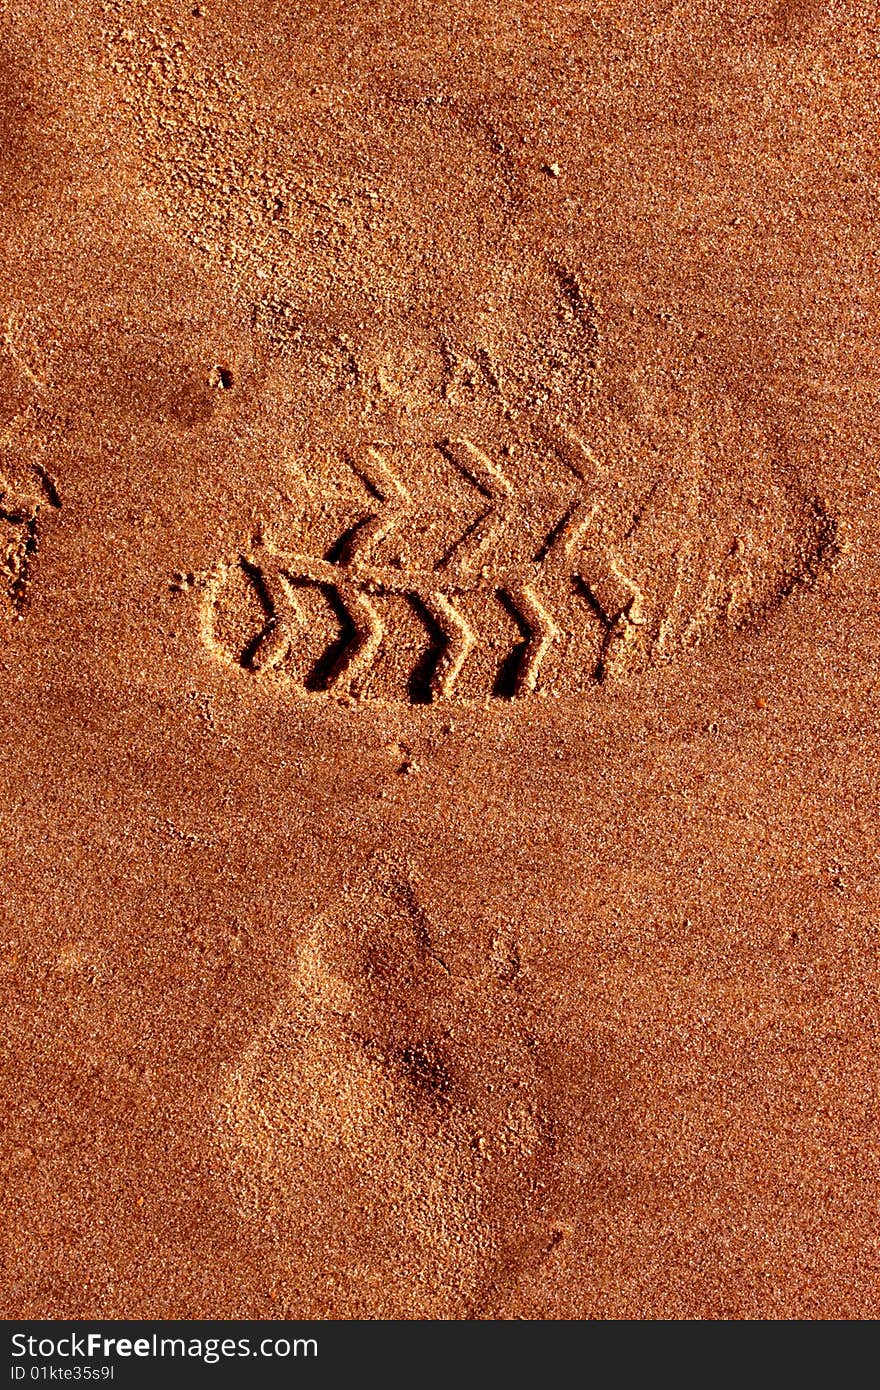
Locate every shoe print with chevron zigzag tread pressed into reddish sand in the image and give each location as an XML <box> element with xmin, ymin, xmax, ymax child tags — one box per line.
<box><xmin>191</xmin><ymin>432</ymin><xmax>837</xmax><ymax>701</ymax></box>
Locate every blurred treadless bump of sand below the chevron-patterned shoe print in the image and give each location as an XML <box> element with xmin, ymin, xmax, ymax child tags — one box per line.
<box><xmin>220</xmin><ymin>883</ymin><xmax>597</xmax><ymax>1318</ymax></box>
